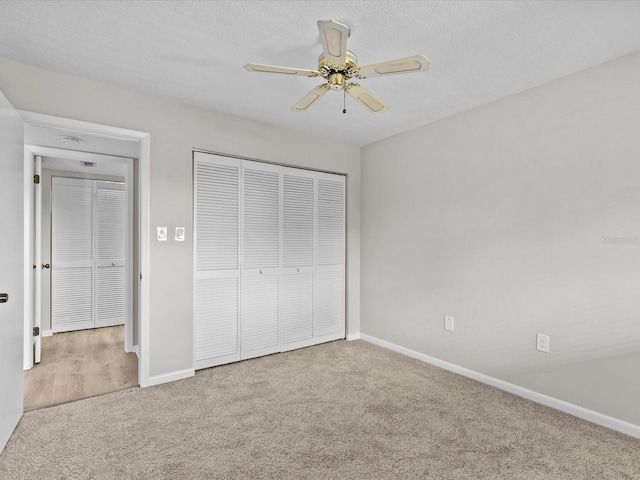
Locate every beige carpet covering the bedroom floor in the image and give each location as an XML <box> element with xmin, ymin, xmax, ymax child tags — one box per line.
<box><xmin>0</xmin><ymin>341</ymin><xmax>640</xmax><ymax>480</ymax></box>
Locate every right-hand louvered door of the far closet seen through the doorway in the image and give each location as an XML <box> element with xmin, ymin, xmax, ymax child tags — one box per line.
<box><xmin>95</xmin><ymin>182</ymin><xmax>127</xmax><ymax>327</ymax></box>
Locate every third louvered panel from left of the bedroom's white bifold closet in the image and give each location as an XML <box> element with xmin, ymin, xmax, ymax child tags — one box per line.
<box><xmin>280</xmin><ymin>167</ymin><xmax>316</xmax><ymax>351</ymax></box>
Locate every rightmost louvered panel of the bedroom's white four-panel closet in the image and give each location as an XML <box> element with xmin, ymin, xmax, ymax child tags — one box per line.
<box><xmin>316</xmin><ymin>173</ymin><xmax>346</xmax><ymax>343</ymax></box>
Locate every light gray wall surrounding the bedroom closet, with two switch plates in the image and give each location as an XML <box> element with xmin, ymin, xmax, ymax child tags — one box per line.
<box><xmin>0</xmin><ymin>60</ymin><xmax>360</xmax><ymax>376</ymax></box>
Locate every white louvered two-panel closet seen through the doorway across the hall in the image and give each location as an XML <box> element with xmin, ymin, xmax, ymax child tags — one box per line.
<box><xmin>51</xmin><ymin>177</ymin><xmax>127</xmax><ymax>333</ymax></box>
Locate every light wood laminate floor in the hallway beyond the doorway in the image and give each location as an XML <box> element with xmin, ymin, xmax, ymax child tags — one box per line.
<box><xmin>24</xmin><ymin>325</ymin><xmax>138</xmax><ymax>412</ymax></box>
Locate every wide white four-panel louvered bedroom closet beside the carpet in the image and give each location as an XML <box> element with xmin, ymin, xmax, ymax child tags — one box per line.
<box><xmin>194</xmin><ymin>152</ymin><xmax>345</xmax><ymax>369</ymax></box>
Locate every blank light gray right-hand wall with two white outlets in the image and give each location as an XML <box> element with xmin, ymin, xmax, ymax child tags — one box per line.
<box><xmin>361</xmin><ymin>54</ymin><xmax>640</xmax><ymax>425</ymax></box>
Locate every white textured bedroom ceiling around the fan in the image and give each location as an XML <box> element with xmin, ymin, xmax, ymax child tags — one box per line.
<box><xmin>0</xmin><ymin>0</ymin><xmax>640</xmax><ymax>145</ymax></box>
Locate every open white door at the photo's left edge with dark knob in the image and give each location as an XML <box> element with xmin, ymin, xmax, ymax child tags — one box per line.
<box><xmin>0</xmin><ymin>88</ymin><xmax>25</xmax><ymax>451</ymax></box>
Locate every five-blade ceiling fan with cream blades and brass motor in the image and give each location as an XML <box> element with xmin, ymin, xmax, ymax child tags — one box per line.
<box><xmin>244</xmin><ymin>20</ymin><xmax>430</xmax><ymax>114</ymax></box>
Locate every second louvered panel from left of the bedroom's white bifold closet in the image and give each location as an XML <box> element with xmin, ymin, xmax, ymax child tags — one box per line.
<box><xmin>240</xmin><ymin>161</ymin><xmax>281</xmax><ymax>359</ymax></box>
